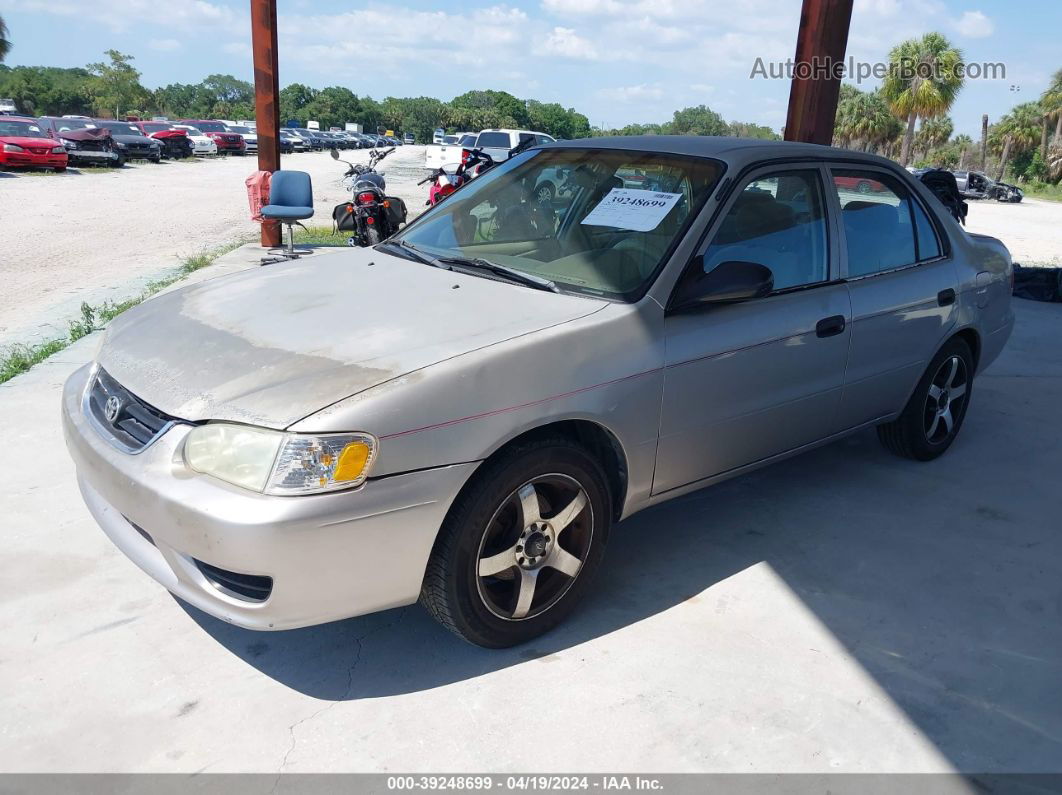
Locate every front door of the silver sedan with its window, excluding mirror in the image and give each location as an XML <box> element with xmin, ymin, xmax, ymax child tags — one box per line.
<box><xmin>653</xmin><ymin>166</ymin><xmax>852</xmax><ymax>494</ymax></box>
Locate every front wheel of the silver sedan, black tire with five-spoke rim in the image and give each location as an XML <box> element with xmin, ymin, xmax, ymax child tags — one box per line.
<box><xmin>421</xmin><ymin>437</ymin><xmax>612</xmax><ymax>649</ymax></box>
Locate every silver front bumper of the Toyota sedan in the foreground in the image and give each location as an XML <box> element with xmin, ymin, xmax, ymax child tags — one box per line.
<box><xmin>63</xmin><ymin>365</ymin><xmax>476</xmax><ymax>629</ymax></box>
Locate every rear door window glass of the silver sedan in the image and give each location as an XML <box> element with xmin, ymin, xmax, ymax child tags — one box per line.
<box><xmin>833</xmin><ymin>169</ymin><xmax>921</xmax><ymax>277</ymax></box>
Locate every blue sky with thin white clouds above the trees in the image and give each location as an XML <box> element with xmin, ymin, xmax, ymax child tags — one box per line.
<box><xmin>0</xmin><ymin>0</ymin><xmax>1062</xmax><ymax>138</ymax></box>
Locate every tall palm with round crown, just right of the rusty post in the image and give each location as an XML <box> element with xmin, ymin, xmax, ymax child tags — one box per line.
<box><xmin>881</xmin><ymin>33</ymin><xmax>964</xmax><ymax>166</ymax></box>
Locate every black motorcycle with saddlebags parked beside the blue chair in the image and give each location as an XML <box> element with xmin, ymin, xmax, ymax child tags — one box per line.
<box><xmin>329</xmin><ymin>146</ymin><xmax>406</xmax><ymax>246</ymax></box>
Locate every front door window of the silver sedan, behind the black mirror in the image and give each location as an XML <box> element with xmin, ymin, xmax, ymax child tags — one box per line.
<box><xmin>704</xmin><ymin>171</ymin><xmax>829</xmax><ymax>290</ymax></box>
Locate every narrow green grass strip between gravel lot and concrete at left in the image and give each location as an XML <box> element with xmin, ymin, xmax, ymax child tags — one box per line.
<box><xmin>0</xmin><ymin>241</ymin><xmax>244</xmax><ymax>383</ymax></box>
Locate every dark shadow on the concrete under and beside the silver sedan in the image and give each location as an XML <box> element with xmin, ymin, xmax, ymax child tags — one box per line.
<box><xmin>185</xmin><ymin>307</ymin><xmax>1062</xmax><ymax>772</ymax></box>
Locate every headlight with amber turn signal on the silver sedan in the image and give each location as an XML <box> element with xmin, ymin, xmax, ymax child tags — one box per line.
<box><xmin>185</xmin><ymin>422</ymin><xmax>376</xmax><ymax>496</ymax></box>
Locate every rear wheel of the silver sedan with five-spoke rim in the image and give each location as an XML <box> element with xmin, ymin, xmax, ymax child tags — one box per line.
<box><xmin>877</xmin><ymin>338</ymin><xmax>974</xmax><ymax>461</ymax></box>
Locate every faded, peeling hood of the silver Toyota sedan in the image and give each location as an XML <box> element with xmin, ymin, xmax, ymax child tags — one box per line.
<box><xmin>99</xmin><ymin>249</ymin><xmax>606</xmax><ymax>428</ymax></box>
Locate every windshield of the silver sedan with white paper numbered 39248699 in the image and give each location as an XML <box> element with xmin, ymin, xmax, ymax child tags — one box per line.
<box><xmin>398</xmin><ymin>149</ymin><xmax>723</xmax><ymax>300</ymax></box>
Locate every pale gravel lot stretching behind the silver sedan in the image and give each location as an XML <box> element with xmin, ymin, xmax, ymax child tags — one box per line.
<box><xmin>0</xmin><ymin>146</ymin><xmax>1062</xmax><ymax>347</ymax></box>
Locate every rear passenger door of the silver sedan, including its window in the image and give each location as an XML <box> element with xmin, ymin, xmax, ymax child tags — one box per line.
<box><xmin>829</xmin><ymin>166</ymin><xmax>958</xmax><ymax>431</ymax></box>
